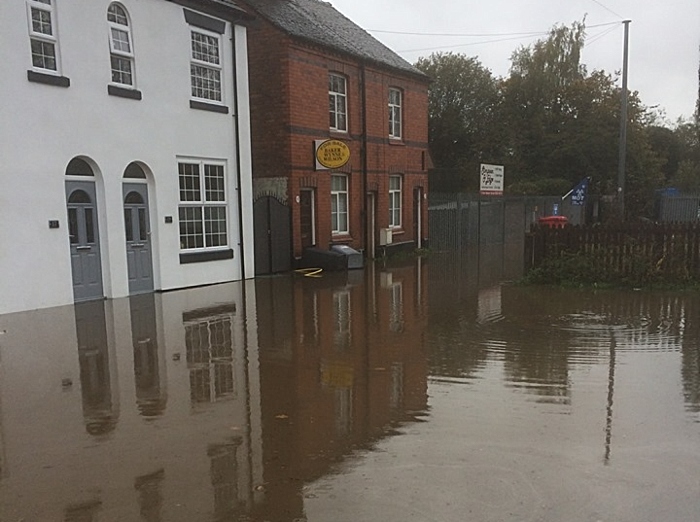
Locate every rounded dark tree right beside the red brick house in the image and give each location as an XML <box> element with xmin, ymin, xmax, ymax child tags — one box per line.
<box><xmin>416</xmin><ymin>53</ymin><xmax>503</xmax><ymax>190</ymax></box>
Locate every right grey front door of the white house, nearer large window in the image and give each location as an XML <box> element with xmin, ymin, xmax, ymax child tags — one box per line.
<box><xmin>124</xmin><ymin>183</ymin><xmax>153</xmax><ymax>294</ymax></box>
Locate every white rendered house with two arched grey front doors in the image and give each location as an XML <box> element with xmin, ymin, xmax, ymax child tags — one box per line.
<box><xmin>0</xmin><ymin>0</ymin><xmax>254</xmax><ymax>314</ymax></box>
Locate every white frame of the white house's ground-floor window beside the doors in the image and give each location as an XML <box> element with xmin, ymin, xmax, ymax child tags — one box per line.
<box><xmin>177</xmin><ymin>158</ymin><xmax>231</xmax><ymax>252</ymax></box>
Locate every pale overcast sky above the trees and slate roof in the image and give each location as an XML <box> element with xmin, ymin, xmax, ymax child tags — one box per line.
<box><xmin>330</xmin><ymin>0</ymin><xmax>700</xmax><ymax>123</ymax></box>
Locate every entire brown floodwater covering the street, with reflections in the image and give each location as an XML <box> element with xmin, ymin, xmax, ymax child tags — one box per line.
<box><xmin>0</xmin><ymin>253</ymin><xmax>700</xmax><ymax>522</ymax></box>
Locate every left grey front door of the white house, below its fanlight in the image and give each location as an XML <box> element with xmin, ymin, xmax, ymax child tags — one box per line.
<box><xmin>66</xmin><ymin>181</ymin><xmax>104</xmax><ymax>301</ymax></box>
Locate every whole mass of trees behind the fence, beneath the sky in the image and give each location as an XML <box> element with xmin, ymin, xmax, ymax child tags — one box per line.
<box><xmin>416</xmin><ymin>21</ymin><xmax>700</xmax><ymax>218</ymax></box>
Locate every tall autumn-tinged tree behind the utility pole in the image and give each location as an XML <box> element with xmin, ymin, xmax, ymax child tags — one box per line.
<box><xmin>502</xmin><ymin>22</ymin><xmax>663</xmax><ymax>217</ymax></box>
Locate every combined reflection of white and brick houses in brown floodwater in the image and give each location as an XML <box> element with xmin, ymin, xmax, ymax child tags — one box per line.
<box><xmin>0</xmin><ymin>264</ymin><xmax>427</xmax><ymax>522</ymax></box>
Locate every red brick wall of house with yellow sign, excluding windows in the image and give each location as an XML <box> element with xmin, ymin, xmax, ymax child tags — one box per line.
<box><xmin>249</xmin><ymin>20</ymin><xmax>428</xmax><ymax>257</ymax></box>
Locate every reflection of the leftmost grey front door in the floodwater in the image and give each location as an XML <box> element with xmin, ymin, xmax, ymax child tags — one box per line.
<box><xmin>75</xmin><ymin>300</ymin><xmax>119</xmax><ymax>435</ymax></box>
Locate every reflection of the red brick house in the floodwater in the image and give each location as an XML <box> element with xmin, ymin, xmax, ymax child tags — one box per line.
<box><xmin>256</xmin><ymin>262</ymin><xmax>428</xmax><ymax>520</ymax></box>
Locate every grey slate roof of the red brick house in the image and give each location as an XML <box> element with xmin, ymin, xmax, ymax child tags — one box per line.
<box><xmin>245</xmin><ymin>0</ymin><xmax>427</xmax><ymax>78</ymax></box>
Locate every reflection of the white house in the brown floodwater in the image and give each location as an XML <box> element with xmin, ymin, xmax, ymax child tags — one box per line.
<box><xmin>0</xmin><ymin>283</ymin><xmax>262</xmax><ymax>522</ymax></box>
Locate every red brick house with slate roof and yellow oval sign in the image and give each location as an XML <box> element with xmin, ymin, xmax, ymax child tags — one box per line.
<box><xmin>240</xmin><ymin>0</ymin><xmax>429</xmax><ymax>273</ymax></box>
